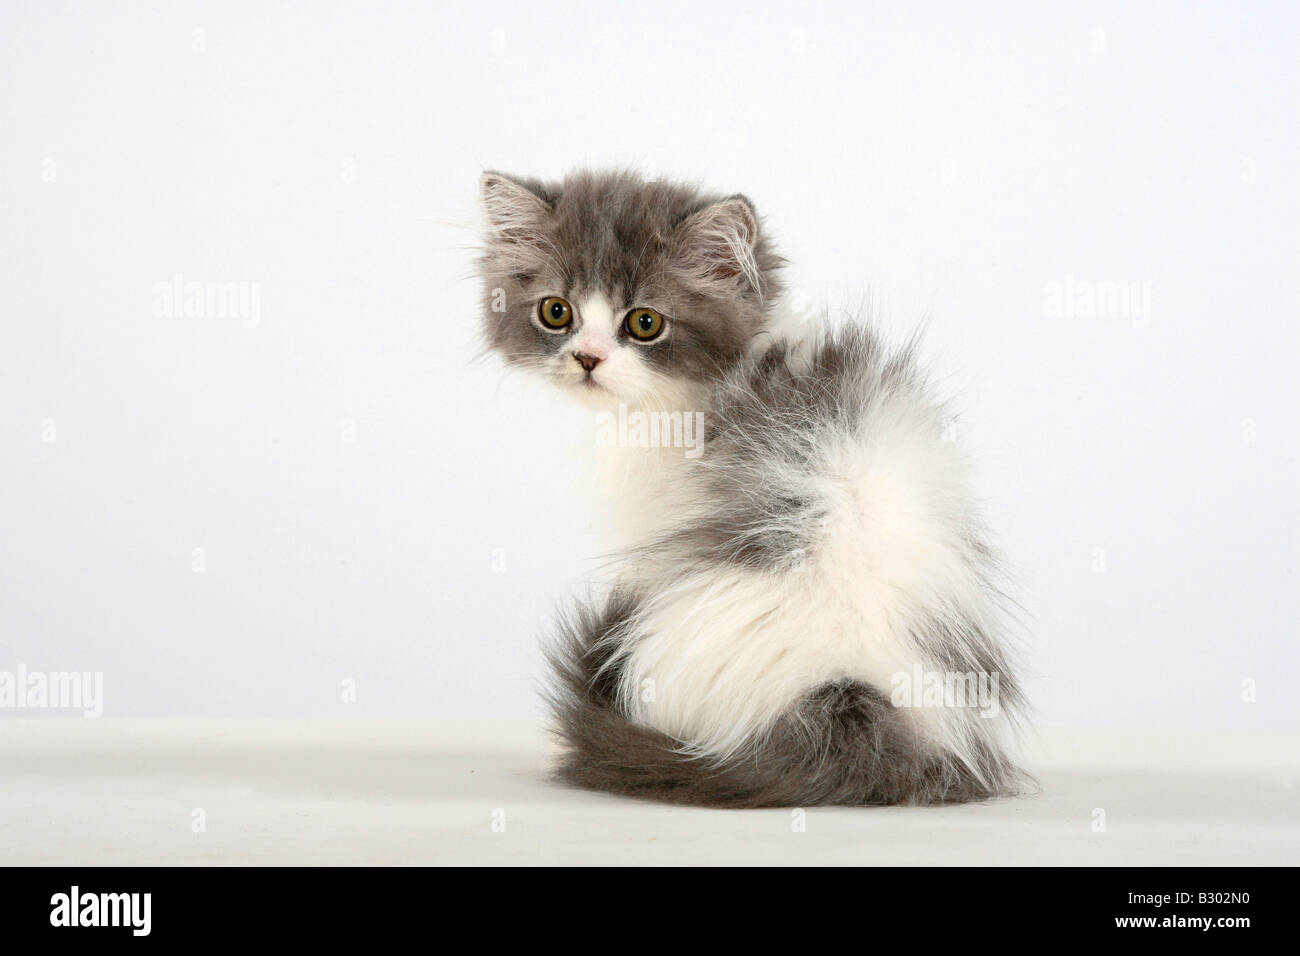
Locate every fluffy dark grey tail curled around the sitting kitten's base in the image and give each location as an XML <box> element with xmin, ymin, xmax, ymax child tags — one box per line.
<box><xmin>549</xmin><ymin>594</ymin><xmax>1030</xmax><ymax>808</ymax></box>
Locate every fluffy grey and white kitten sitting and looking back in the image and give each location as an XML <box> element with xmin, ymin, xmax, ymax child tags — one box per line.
<box><xmin>481</xmin><ymin>172</ymin><xmax>1026</xmax><ymax>806</ymax></box>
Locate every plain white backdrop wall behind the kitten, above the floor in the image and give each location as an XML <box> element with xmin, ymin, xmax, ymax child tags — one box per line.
<box><xmin>0</xmin><ymin>3</ymin><xmax>1300</xmax><ymax>728</ymax></box>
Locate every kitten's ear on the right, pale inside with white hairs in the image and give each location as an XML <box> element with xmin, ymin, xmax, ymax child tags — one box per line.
<box><xmin>677</xmin><ymin>195</ymin><xmax>763</xmax><ymax>295</ymax></box>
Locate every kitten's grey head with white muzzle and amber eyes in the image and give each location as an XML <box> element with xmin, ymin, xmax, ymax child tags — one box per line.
<box><xmin>481</xmin><ymin>173</ymin><xmax>780</xmax><ymax>405</ymax></box>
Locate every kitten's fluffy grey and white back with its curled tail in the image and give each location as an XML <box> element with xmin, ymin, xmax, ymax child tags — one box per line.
<box><xmin>551</xmin><ymin>328</ymin><xmax>1026</xmax><ymax>806</ymax></box>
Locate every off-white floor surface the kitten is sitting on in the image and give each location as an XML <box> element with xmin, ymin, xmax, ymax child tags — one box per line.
<box><xmin>0</xmin><ymin>718</ymin><xmax>1300</xmax><ymax>865</ymax></box>
